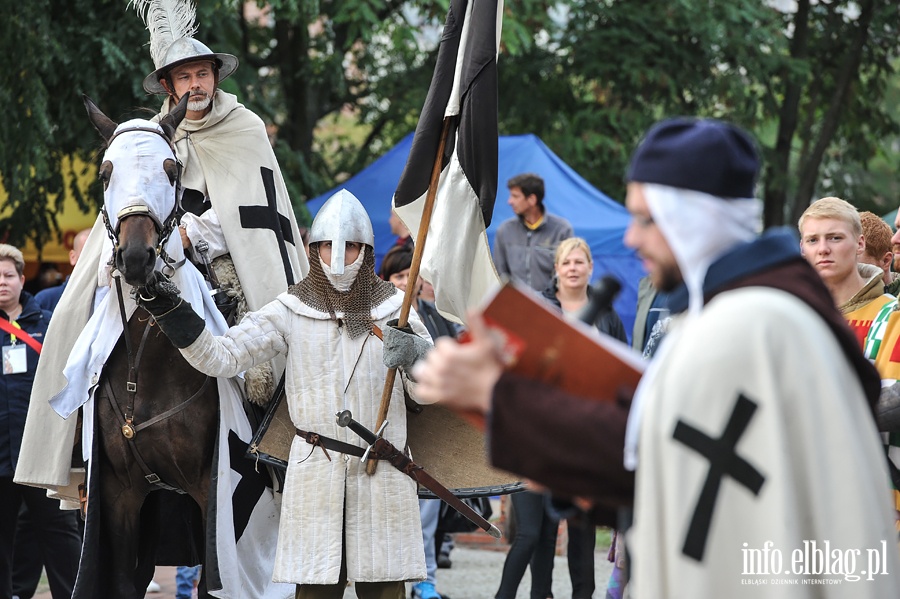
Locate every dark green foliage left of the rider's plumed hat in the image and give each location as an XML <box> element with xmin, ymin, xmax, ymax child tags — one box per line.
<box><xmin>0</xmin><ymin>0</ymin><xmax>146</xmax><ymax>246</ymax></box>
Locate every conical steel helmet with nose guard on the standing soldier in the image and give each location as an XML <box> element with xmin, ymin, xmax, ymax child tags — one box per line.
<box><xmin>309</xmin><ymin>189</ymin><xmax>375</xmax><ymax>275</ymax></box>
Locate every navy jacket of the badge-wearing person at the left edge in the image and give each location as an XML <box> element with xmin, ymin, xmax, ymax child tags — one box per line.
<box><xmin>0</xmin><ymin>291</ymin><xmax>50</xmax><ymax>478</ymax></box>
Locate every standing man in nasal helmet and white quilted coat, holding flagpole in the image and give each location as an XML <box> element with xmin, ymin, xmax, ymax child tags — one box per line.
<box><xmin>138</xmin><ymin>190</ymin><xmax>431</xmax><ymax>599</ymax></box>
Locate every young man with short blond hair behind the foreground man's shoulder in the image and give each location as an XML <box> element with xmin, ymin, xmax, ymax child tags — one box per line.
<box><xmin>798</xmin><ymin>197</ymin><xmax>895</xmax><ymax>346</ymax></box>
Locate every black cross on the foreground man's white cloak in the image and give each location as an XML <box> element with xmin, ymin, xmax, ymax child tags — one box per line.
<box><xmin>672</xmin><ymin>393</ymin><xmax>766</xmax><ymax>562</ymax></box>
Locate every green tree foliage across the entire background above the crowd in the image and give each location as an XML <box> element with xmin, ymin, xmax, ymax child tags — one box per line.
<box><xmin>0</xmin><ymin>0</ymin><xmax>900</xmax><ymax>250</ymax></box>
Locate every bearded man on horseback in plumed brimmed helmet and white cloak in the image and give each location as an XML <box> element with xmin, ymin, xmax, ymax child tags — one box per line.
<box><xmin>134</xmin><ymin>0</ymin><xmax>309</xmax><ymax>404</ymax></box>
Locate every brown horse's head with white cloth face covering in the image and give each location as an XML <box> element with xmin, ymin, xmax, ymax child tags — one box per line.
<box><xmin>83</xmin><ymin>94</ymin><xmax>188</xmax><ymax>286</ymax></box>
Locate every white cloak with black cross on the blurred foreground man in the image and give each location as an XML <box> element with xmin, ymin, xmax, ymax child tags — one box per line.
<box><xmin>626</xmin><ymin>287</ymin><xmax>900</xmax><ymax>599</ymax></box>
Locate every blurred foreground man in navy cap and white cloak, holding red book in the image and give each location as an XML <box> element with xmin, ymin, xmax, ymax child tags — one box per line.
<box><xmin>414</xmin><ymin>119</ymin><xmax>900</xmax><ymax>599</ymax></box>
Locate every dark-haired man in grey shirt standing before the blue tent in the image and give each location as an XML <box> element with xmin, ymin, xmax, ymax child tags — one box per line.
<box><xmin>493</xmin><ymin>173</ymin><xmax>573</xmax><ymax>293</ymax></box>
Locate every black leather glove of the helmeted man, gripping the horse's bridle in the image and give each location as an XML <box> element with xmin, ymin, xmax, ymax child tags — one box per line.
<box><xmin>134</xmin><ymin>271</ymin><xmax>206</xmax><ymax>349</ymax></box>
